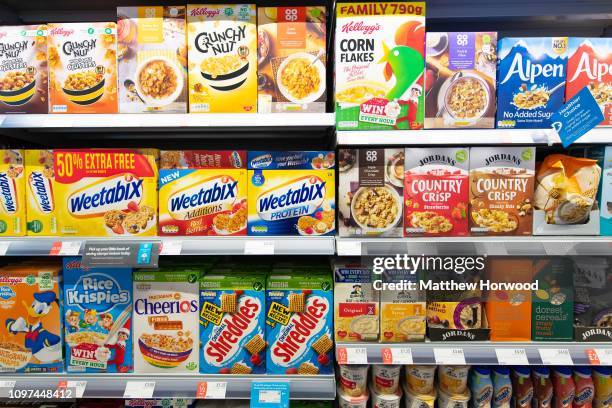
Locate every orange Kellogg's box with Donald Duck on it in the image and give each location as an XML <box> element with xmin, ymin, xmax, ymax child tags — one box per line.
<box><xmin>0</xmin><ymin>263</ymin><xmax>64</xmax><ymax>373</ymax></box>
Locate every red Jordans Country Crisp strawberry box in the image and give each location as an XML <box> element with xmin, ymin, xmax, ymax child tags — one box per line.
<box><xmin>404</xmin><ymin>147</ymin><xmax>470</xmax><ymax>237</ymax></box>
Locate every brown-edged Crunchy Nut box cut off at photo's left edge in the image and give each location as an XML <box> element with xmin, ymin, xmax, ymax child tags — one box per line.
<box><xmin>0</xmin><ymin>25</ymin><xmax>49</xmax><ymax>114</ymax></box>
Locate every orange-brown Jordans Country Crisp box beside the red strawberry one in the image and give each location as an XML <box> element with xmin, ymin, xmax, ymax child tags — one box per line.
<box><xmin>469</xmin><ymin>146</ymin><xmax>535</xmax><ymax>235</ymax></box>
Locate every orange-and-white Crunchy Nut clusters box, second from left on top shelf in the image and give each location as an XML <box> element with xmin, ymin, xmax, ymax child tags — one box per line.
<box><xmin>47</xmin><ymin>22</ymin><xmax>118</xmax><ymax>113</ymax></box>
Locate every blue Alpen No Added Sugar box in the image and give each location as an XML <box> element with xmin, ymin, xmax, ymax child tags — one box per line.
<box><xmin>497</xmin><ymin>37</ymin><xmax>567</xmax><ymax>129</ymax></box>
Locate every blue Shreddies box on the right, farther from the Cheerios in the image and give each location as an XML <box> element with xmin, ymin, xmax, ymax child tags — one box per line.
<box><xmin>266</xmin><ymin>272</ymin><xmax>334</xmax><ymax>375</ymax></box>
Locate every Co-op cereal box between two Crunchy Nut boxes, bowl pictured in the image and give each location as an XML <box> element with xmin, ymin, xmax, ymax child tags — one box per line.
<box><xmin>117</xmin><ymin>6</ymin><xmax>187</xmax><ymax>113</ymax></box>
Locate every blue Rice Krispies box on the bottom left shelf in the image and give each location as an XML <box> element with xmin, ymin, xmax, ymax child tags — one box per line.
<box><xmin>63</xmin><ymin>258</ymin><xmax>134</xmax><ymax>373</ymax></box>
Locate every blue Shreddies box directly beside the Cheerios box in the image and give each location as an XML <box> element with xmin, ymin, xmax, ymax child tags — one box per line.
<box><xmin>200</xmin><ymin>270</ymin><xmax>266</xmax><ymax>374</ymax></box>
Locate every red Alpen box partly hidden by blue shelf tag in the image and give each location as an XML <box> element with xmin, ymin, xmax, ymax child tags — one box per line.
<box><xmin>565</xmin><ymin>37</ymin><xmax>612</xmax><ymax>126</ymax></box>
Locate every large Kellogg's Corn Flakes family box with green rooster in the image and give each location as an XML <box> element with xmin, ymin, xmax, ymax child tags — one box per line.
<box><xmin>335</xmin><ymin>2</ymin><xmax>425</xmax><ymax>130</ymax></box>
